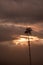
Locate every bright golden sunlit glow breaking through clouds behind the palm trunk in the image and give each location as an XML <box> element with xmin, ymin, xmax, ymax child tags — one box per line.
<box><xmin>12</xmin><ymin>35</ymin><xmax>39</xmax><ymax>45</ymax></box>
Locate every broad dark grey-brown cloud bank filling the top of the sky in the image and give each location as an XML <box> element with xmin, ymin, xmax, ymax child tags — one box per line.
<box><xmin>0</xmin><ymin>0</ymin><xmax>43</xmax><ymax>20</ymax></box>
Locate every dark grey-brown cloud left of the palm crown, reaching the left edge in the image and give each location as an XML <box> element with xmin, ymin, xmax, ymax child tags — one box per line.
<box><xmin>0</xmin><ymin>23</ymin><xmax>24</xmax><ymax>42</ymax></box>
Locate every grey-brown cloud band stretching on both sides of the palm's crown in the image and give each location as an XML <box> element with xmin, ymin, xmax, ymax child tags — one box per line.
<box><xmin>0</xmin><ymin>23</ymin><xmax>43</xmax><ymax>42</ymax></box>
